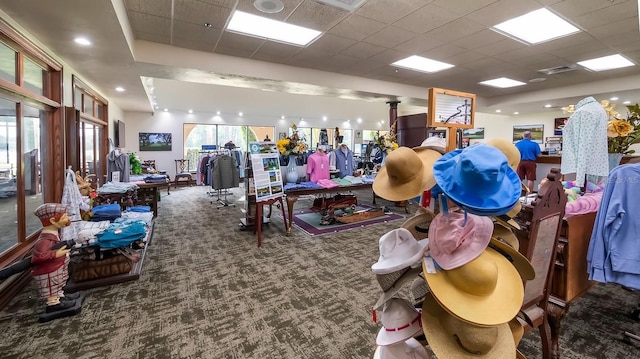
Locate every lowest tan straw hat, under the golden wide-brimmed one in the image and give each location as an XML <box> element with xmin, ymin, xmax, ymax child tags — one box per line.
<box><xmin>422</xmin><ymin>294</ymin><xmax>516</xmax><ymax>359</ymax></box>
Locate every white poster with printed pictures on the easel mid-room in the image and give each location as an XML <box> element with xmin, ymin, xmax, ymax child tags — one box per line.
<box><xmin>249</xmin><ymin>142</ymin><xmax>284</xmax><ymax>202</ymax></box>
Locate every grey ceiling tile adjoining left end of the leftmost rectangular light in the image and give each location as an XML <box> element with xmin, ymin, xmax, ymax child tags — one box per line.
<box><xmin>173</xmin><ymin>0</ymin><xmax>231</xmax><ymax>29</ymax></box>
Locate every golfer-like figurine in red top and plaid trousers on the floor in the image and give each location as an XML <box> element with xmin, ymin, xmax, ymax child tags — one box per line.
<box><xmin>31</xmin><ymin>203</ymin><xmax>81</xmax><ymax>320</ymax></box>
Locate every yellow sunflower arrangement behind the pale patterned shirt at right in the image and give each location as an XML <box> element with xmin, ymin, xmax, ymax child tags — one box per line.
<box><xmin>563</xmin><ymin>100</ymin><xmax>640</xmax><ymax>155</ymax></box>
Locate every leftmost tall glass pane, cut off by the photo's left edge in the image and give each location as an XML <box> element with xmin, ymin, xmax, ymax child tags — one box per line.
<box><xmin>0</xmin><ymin>98</ymin><xmax>18</xmax><ymax>252</ymax></box>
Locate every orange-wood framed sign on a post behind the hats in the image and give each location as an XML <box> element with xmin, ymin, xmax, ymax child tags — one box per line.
<box><xmin>427</xmin><ymin>88</ymin><xmax>476</xmax><ymax>151</ymax></box>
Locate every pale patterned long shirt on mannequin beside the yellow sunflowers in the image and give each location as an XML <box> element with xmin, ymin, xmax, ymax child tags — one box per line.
<box><xmin>560</xmin><ymin>97</ymin><xmax>609</xmax><ymax>187</ymax></box>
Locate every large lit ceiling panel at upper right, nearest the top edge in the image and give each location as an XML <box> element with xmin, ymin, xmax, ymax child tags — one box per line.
<box><xmin>491</xmin><ymin>8</ymin><xmax>580</xmax><ymax>45</ymax></box>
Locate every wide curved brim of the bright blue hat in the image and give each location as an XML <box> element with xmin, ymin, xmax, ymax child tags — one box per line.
<box><xmin>433</xmin><ymin>150</ymin><xmax>522</xmax><ymax>216</ymax></box>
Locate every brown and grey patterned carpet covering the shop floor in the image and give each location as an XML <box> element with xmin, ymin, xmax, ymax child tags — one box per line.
<box><xmin>0</xmin><ymin>187</ymin><xmax>640</xmax><ymax>359</ymax></box>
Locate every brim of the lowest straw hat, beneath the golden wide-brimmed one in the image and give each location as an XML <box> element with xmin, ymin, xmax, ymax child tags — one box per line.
<box><xmin>422</xmin><ymin>294</ymin><xmax>516</xmax><ymax>359</ymax></box>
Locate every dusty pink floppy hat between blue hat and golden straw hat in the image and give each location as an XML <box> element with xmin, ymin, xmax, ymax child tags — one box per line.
<box><xmin>429</xmin><ymin>212</ymin><xmax>493</xmax><ymax>270</ymax></box>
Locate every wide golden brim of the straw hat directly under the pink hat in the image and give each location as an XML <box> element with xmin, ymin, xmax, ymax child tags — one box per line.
<box><xmin>422</xmin><ymin>248</ymin><xmax>524</xmax><ymax>325</ymax></box>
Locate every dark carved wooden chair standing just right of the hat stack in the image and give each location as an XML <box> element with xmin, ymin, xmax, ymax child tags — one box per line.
<box><xmin>514</xmin><ymin>168</ymin><xmax>567</xmax><ymax>359</ymax></box>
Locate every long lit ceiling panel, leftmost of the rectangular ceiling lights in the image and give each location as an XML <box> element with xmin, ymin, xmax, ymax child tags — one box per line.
<box><xmin>227</xmin><ymin>10</ymin><xmax>321</xmax><ymax>46</ymax></box>
